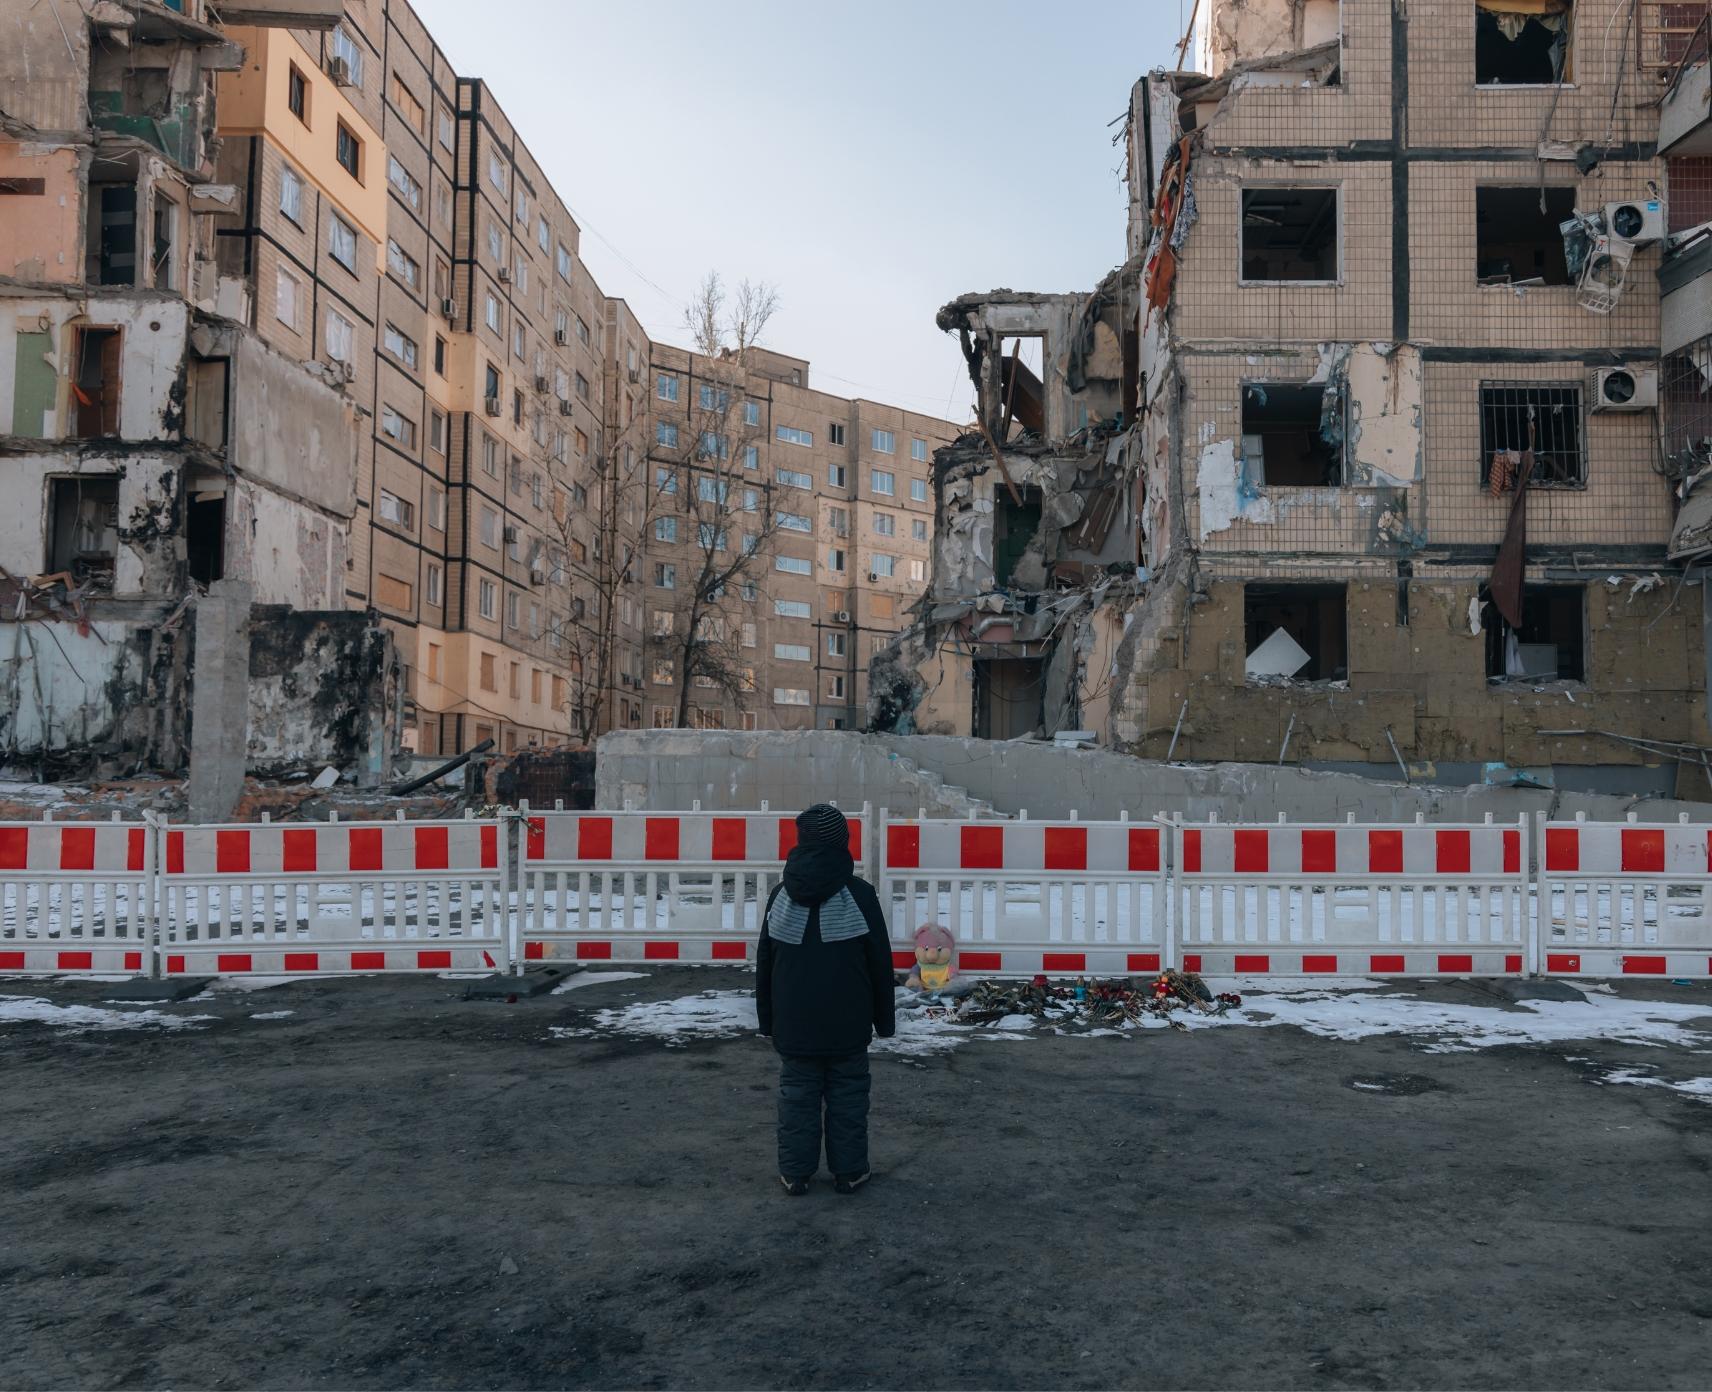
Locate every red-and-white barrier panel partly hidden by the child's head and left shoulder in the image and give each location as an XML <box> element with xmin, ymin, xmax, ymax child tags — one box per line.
<box><xmin>519</xmin><ymin>812</ymin><xmax>868</xmax><ymax>962</ymax></box>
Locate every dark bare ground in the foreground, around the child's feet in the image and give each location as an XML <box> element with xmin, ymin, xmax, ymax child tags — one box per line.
<box><xmin>0</xmin><ymin>969</ymin><xmax>1712</xmax><ymax>1389</ymax></box>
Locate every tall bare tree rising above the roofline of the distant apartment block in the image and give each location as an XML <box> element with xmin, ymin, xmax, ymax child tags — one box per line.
<box><xmin>649</xmin><ymin>272</ymin><xmax>779</xmax><ymax>726</ymax></box>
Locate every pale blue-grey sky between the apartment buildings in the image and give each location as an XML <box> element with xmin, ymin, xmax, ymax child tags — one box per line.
<box><xmin>416</xmin><ymin>0</ymin><xmax>1183</xmax><ymax>419</ymax></box>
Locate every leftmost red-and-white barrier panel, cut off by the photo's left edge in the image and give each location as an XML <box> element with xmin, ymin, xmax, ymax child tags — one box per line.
<box><xmin>0</xmin><ymin>820</ymin><xmax>154</xmax><ymax>974</ymax></box>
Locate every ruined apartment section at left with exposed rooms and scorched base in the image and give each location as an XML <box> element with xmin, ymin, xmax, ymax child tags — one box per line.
<box><xmin>0</xmin><ymin>0</ymin><xmax>397</xmax><ymax>774</ymax></box>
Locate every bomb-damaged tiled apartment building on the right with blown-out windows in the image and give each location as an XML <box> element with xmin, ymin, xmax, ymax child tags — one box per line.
<box><xmin>870</xmin><ymin>0</ymin><xmax>1712</xmax><ymax>796</ymax></box>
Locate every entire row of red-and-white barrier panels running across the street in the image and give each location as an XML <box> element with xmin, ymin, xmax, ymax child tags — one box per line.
<box><xmin>10</xmin><ymin>805</ymin><xmax>1712</xmax><ymax>978</ymax></box>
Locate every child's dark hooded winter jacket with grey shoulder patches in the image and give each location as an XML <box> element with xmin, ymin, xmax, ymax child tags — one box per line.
<box><xmin>755</xmin><ymin>846</ymin><xmax>897</xmax><ymax>1058</ymax></box>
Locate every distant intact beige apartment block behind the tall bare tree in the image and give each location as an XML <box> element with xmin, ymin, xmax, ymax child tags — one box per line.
<box><xmin>642</xmin><ymin>344</ymin><xmax>957</xmax><ymax>729</ymax></box>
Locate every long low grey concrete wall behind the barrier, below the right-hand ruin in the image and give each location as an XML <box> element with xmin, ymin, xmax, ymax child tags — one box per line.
<box><xmin>596</xmin><ymin>729</ymin><xmax>1712</xmax><ymax>822</ymax></box>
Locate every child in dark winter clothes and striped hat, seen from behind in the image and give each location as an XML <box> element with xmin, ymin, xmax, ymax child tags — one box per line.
<box><xmin>755</xmin><ymin>803</ymin><xmax>897</xmax><ymax>1193</ymax></box>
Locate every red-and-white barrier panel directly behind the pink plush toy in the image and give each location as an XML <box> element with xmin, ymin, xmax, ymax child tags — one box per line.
<box><xmin>880</xmin><ymin>820</ymin><xmax>1169</xmax><ymax>976</ymax></box>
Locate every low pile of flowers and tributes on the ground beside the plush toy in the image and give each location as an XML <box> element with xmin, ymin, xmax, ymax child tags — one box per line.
<box><xmin>923</xmin><ymin>971</ymin><xmax>1243</xmax><ymax>1029</ymax></box>
